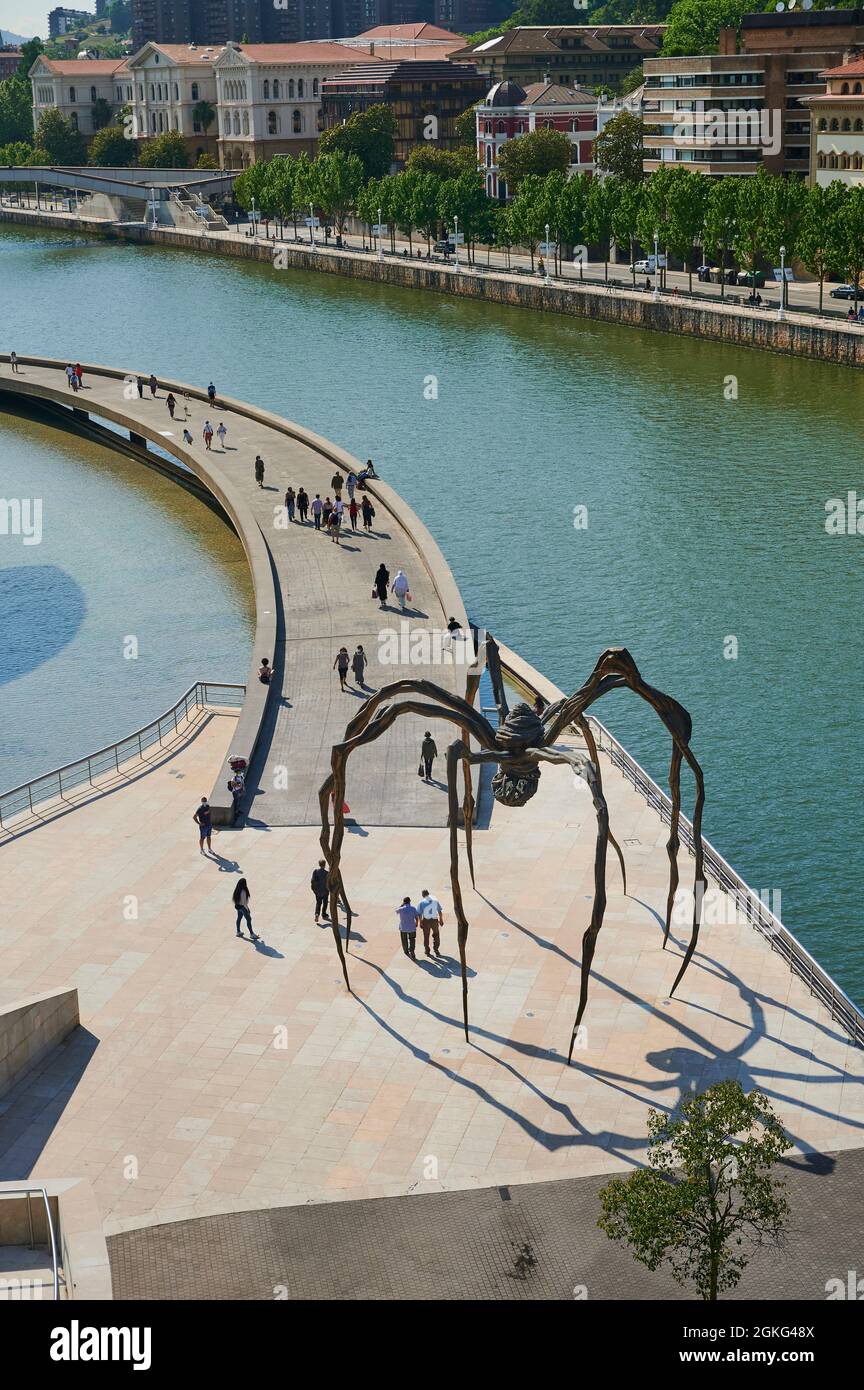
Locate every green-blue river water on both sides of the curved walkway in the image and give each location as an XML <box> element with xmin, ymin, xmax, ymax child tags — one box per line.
<box><xmin>0</xmin><ymin>228</ymin><xmax>864</xmax><ymax>1001</ymax></box>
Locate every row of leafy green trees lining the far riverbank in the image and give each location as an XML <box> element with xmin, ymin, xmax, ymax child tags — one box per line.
<box><xmin>235</xmin><ymin>152</ymin><xmax>864</xmax><ymax>309</ymax></box>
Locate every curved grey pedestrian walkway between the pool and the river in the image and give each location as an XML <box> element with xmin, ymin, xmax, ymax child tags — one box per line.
<box><xmin>0</xmin><ymin>357</ymin><xmax>467</xmax><ymax>826</ymax></box>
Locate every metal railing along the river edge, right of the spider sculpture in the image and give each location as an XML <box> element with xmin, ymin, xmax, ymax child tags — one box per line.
<box><xmin>488</xmin><ymin>660</ymin><xmax>864</xmax><ymax>1047</ymax></box>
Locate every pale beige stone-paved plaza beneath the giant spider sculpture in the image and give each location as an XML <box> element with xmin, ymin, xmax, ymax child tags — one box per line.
<box><xmin>0</xmin><ymin>716</ymin><xmax>864</xmax><ymax>1233</ymax></box>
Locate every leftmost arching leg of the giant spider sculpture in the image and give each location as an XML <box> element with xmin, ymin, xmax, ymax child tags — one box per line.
<box><xmin>318</xmin><ymin>695</ymin><xmax>495</xmax><ymax>990</ymax></box>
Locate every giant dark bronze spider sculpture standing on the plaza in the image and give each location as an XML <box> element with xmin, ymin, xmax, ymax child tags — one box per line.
<box><xmin>318</xmin><ymin>637</ymin><xmax>706</xmax><ymax>1063</ymax></box>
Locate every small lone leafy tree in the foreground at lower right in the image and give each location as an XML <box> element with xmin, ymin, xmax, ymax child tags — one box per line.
<box><xmin>597</xmin><ymin>1081</ymin><xmax>792</xmax><ymax>1302</ymax></box>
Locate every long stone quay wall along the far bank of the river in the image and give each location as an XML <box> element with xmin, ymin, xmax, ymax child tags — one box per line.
<box><xmin>0</xmin><ymin>209</ymin><xmax>864</xmax><ymax>368</ymax></box>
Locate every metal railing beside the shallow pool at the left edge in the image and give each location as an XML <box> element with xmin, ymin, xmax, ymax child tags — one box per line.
<box><xmin>0</xmin><ymin>681</ymin><xmax>246</xmax><ymax>827</ymax></box>
